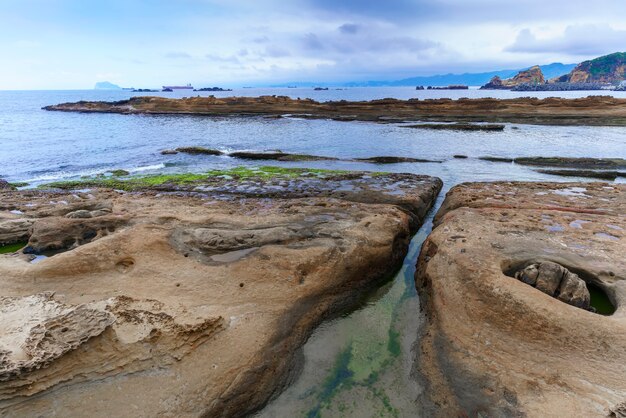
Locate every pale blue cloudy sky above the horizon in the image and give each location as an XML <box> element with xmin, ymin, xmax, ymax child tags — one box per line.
<box><xmin>0</xmin><ymin>0</ymin><xmax>626</xmax><ymax>89</ymax></box>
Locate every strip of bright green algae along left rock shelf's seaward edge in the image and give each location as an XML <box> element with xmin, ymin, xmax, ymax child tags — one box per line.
<box><xmin>39</xmin><ymin>166</ymin><xmax>370</xmax><ymax>191</ymax></box>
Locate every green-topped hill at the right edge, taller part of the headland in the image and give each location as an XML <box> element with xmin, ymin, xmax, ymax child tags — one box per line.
<box><xmin>551</xmin><ymin>52</ymin><xmax>626</xmax><ymax>84</ymax></box>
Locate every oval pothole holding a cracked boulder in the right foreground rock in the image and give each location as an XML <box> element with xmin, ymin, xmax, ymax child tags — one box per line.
<box><xmin>504</xmin><ymin>261</ymin><xmax>615</xmax><ymax>315</ymax></box>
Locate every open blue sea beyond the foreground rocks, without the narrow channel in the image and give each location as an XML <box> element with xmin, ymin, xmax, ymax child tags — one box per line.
<box><xmin>0</xmin><ymin>87</ymin><xmax>626</xmax><ymax>185</ymax></box>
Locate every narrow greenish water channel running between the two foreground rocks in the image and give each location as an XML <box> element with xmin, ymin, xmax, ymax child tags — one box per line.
<box><xmin>255</xmin><ymin>190</ymin><xmax>447</xmax><ymax>418</ymax></box>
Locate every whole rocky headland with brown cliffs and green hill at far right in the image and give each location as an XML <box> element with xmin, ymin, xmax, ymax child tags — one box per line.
<box><xmin>481</xmin><ymin>52</ymin><xmax>626</xmax><ymax>91</ymax></box>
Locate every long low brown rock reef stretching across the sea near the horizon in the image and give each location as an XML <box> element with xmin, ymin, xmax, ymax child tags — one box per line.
<box><xmin>44</xmin><ymin>96</ymin><xmax>626</xmax><ymax>126</ymax></box>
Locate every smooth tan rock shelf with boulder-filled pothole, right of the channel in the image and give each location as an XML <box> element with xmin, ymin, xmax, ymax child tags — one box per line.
<box><xmin>415</xmin><ymin>182</ymin><xmax>626</xmax><ymax>417</ymax></box>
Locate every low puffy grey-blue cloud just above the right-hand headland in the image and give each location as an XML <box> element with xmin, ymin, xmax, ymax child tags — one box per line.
<box><xmin>506</xmin><ymin>25</ymin><xmax>626</xmax><ymax>56</ymax></box>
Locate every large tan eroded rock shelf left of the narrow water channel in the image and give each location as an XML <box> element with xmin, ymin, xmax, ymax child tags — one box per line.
<box><xmin>0</xmin><ymin>172</ymin><xmax>441</xmax><ymax>417</ymax></box>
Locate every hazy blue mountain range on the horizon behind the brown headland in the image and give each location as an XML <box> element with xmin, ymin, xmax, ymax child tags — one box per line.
<box><xmin>272</xmin><ymin>62</ymin><xmax>576</xmax><ymax>87</ymax></box>
